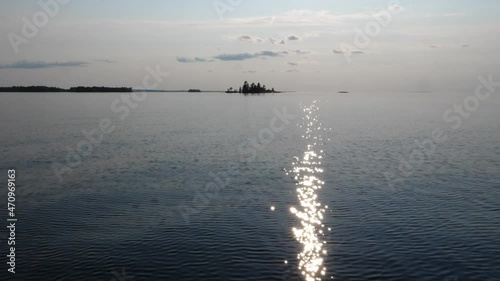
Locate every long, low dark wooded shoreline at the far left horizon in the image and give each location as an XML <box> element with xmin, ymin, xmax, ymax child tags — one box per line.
<box><xmin>0</xmin><ymin>86</ymin><xmax>132</xmax><ymax>93</ymax></box>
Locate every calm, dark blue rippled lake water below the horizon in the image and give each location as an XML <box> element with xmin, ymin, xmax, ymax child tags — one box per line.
<box><xmin>0</xmin><ymin>93</ymin><xmax>500</xmax><ymax>281</ymax></box>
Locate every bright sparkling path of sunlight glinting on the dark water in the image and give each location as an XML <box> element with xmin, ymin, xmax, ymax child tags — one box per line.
<box><xmin>290</xmin><ymin>101</ymin><xmax>327</xmax><ymax>281</ymax></box>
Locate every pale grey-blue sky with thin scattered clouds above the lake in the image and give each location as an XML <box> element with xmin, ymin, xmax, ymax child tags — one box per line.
<box><xmin>0</xmin><ymin>0</ymin><xmax>500</xmax><ymax>92</ymax></box>
